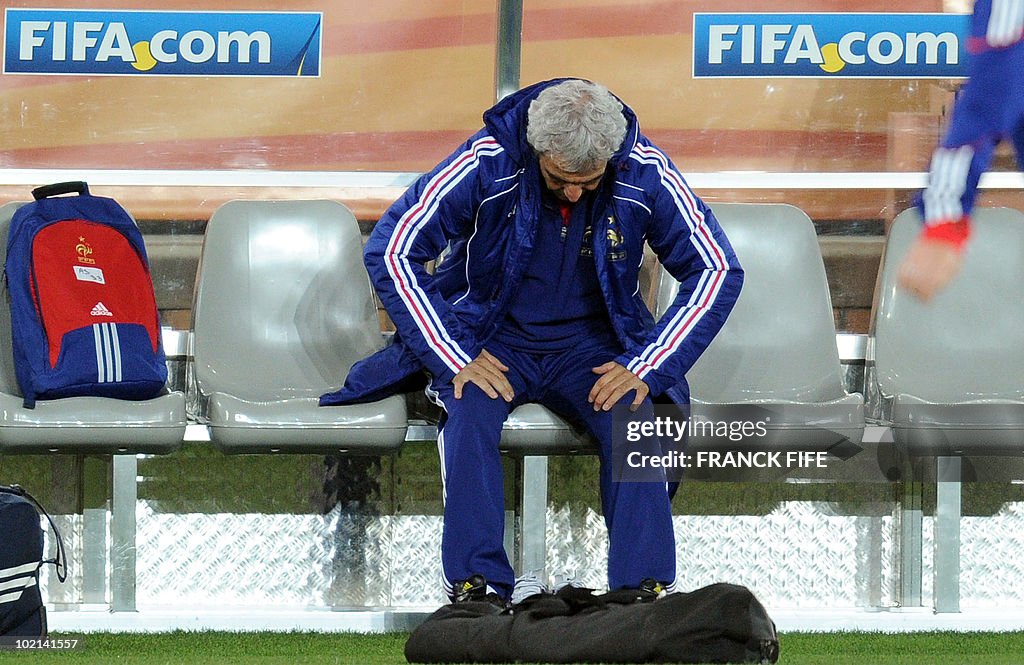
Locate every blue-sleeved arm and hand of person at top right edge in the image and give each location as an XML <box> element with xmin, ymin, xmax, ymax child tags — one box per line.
<box><xmin>897</xmin><ymin>0</ymin><xmax>1024</xmax><ymax>301</ymax></box>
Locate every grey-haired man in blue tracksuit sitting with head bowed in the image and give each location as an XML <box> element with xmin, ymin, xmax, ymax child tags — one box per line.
<box><xmin>322</xmin><ymin>79</ymin><xmax>742</xmax><ymax>601</ymax></box>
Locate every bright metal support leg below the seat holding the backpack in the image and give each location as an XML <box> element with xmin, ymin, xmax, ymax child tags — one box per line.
<box><xmin>111</xmin><ymin>455</ymin><xmax>138</xmax><ymax>612</ymax></box>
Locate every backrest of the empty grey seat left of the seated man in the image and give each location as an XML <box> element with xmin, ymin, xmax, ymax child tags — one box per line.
<box><xmin>193</xmin><ymin>201</ymin><xmax>382</xmax><ymax>401</ymax></box>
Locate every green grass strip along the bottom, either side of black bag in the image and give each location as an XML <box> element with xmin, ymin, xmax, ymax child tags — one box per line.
<box><xmin>6</xmin><ymin>632</ymin><xmax>1024</xmax><ymax>665</ymax></box>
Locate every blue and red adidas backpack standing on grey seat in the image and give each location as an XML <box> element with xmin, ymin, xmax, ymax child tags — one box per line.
<box><xmin>4</xmin><ymin>182</ymin><xmax>167</xmax><ymax>409</ymax></box>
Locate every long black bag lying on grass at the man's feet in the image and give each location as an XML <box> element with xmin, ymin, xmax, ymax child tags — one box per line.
<box><xmin>406</xmin><ymin>584</ymin><xmax>779</xmax><ymax>663</ymax></box>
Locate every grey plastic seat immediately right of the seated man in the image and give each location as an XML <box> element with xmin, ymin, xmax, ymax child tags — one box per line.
<box><xmin>655</xmin><ymin>203</ymin><xmax>864</xmax><ymax>450</ymax></box>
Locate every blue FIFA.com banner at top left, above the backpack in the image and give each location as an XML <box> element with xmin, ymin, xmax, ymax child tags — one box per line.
<box><xmin>3</xmin><ymin>8</ymin><xmax>323</xmax><ymax>77</ymax></box>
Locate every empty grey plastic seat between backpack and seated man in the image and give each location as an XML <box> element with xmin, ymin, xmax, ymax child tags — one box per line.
<box><xmin>191</xmin><ymin>201</ymin><xmax>408</xmax><ymax>454</ymax></box>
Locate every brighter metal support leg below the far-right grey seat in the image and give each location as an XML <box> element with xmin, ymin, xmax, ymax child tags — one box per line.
<box><xmin>933</xmin><ymin>457</ymin><xmax>962</xmax><ymax>612</ymax></box>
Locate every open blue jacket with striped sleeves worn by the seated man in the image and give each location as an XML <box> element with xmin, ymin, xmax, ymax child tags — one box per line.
<box><xmin>321</xmin><ymin>80</ymin><xmax>742</xmax><ymax>405</ymax></box>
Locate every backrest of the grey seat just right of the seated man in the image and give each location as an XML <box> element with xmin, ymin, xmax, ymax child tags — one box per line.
<box><xmin>655</xmin><ymin>203</ymin><xmax>846</xmax><ymax>404</ymax></box>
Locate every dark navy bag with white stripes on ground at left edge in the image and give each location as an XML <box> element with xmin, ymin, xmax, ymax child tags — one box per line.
<box><xmin>0</xmin><ymin>485</ymin><xmax>68</xmax><ymax>637</ymax></box>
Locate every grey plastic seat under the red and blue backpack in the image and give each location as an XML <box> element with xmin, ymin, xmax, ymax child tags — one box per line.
<box><xmin>0</xmin><ymin>202</ymin><xmax>186</xmax><ymax>454</ymax></box>
